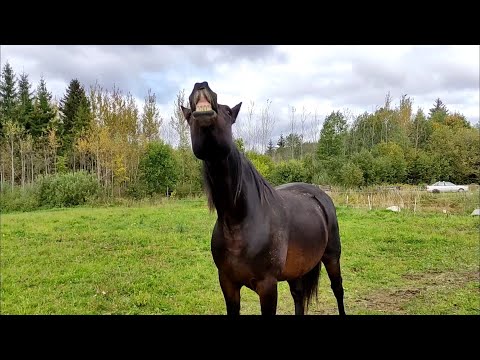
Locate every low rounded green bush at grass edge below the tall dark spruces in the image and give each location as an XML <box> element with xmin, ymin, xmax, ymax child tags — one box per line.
<box><xmin>36</xmin><ymin>171</ymin><xmax>101</xmax><ymax>207</ymax></box>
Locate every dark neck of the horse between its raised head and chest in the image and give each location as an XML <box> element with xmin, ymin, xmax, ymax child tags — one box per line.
<box><xmin>205</xmin><ymin>149</ymin><xmax>257</xmax><ymax>223</ymax></box>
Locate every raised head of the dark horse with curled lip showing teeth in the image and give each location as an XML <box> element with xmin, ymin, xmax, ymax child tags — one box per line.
<box><xmin>182</xmin><ymin>81</ymin><xmax>242</xmax><ymax>160</ymax></box>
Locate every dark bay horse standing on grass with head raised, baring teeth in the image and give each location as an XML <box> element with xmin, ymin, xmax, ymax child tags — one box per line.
<box><xmin>182</xmin><ymin>82</ymin><xmax>345</xmax><ymax>315</ymax></box>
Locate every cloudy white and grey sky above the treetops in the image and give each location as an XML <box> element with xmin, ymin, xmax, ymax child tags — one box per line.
<box><xmin>1</xmin><ymin>45</ymin><xmax>480</xmax><ymax>145</ymax></box>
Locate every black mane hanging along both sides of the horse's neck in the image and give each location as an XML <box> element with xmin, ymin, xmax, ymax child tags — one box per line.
<box><xmin>203</xmin><ymin>146</ymin><xmax>277</xmax><ymax>211</ymax></box>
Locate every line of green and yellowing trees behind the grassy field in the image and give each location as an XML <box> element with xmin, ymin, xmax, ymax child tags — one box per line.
<box><xmin>0</xmin><ymin>63</ymin><xmax>480</xmax><ymax>204</ymax></box>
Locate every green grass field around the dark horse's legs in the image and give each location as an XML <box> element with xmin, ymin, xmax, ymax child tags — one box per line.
<box><xmin>1</xmin><ymin>200</ymin><xmax>480</xmax><ymax>315</ymax></box>
